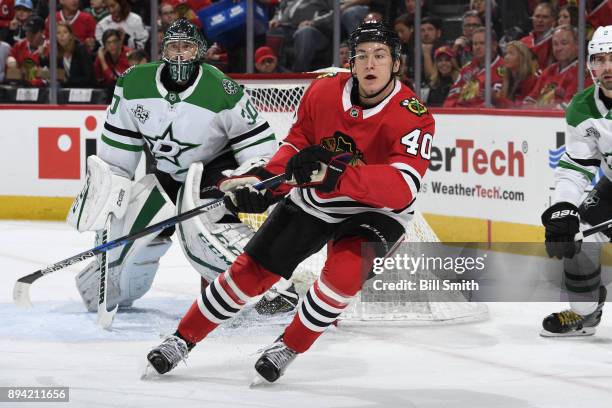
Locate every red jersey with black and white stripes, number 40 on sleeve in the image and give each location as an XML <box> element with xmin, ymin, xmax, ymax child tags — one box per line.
<box><xmin>266</xmin><ymin>73</ymin><xmax>435</xmax><ymax>231</ymax></box>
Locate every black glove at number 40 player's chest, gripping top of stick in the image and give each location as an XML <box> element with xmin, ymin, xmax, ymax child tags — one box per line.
<box><xmin>285</xmin><ymin>146</ymin><xmax>351</xmax><ymax>193</ymax></box>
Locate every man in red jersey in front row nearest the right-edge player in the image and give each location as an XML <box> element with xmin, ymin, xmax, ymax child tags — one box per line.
<box><xmin>525</xmin><ymin>25</ymin><xmax>591</xmax><ymax>108</ymax></box>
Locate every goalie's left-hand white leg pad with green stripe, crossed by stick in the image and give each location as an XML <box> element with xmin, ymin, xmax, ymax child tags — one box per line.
<box><xmin>76</xmin><ymin>174</ymin><xmax>175</xmax><ymax>311</ymax></box>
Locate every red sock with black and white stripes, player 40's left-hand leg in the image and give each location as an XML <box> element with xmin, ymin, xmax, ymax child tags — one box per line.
<box><xmin>178</xmin><ymin>254</ymin><xmax>280</xmax><ymax>343</ymax></box>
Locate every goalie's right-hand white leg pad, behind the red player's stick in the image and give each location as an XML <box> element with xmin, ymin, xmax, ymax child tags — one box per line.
<box><xmin>177</xmin><ymin>163</ymin><xmax>253</xmax><ymax>282</ymax></box>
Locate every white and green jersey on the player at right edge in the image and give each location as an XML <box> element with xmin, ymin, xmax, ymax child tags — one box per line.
<box><xmin>554</xmin><ymin>86</ymin><xmax>612</xmax><ymax>206</ymax></box>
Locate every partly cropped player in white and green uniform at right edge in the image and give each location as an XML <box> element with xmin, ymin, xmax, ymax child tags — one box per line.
<box><xmin>541</xmin><ymin>26</ymin><xmax>612</xmax><ymax>337</ymax></box>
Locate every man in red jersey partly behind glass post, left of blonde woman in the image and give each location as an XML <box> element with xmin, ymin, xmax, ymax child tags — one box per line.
<box><xmin>444</xmin><ymin>27</ymin><xmax>504</xmax><ymax>107</ymax></box>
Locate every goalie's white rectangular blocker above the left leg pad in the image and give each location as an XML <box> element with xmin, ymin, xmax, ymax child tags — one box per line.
<box><xmin>66</xmin><ymin>156</ymin><xmax>132</xmax><ymax>232</ymax></box>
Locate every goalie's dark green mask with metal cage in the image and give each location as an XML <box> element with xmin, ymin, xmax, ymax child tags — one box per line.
<box><xmin>162</xmin><ymin>19</ymin><xmax>206</xmax><ymax>84</ymax></box>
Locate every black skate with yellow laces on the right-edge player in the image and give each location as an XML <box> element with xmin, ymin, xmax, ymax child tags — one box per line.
<box><xmin>540</xmin><ymin>286</ymin><xmax>607</xmax><ymax>337</ymax></box>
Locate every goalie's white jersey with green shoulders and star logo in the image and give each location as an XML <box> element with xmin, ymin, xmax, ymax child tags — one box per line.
<box><xmin>98</xmin><ymin>62</ymin><xmax>278</xmax><ymax>181</ymax></box>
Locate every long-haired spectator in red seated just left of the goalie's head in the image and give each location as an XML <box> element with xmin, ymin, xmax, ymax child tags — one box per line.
<box><xmin>94</xmin><ymin>28</ymin><xmax>130</xmax><ymax>88</ymax></box>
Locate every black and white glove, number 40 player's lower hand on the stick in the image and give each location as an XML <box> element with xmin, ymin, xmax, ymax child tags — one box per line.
<box><xmin>219</xmin><ymin>169</ymin><xmax>282</xmax><ymax>214</ymax></box>
